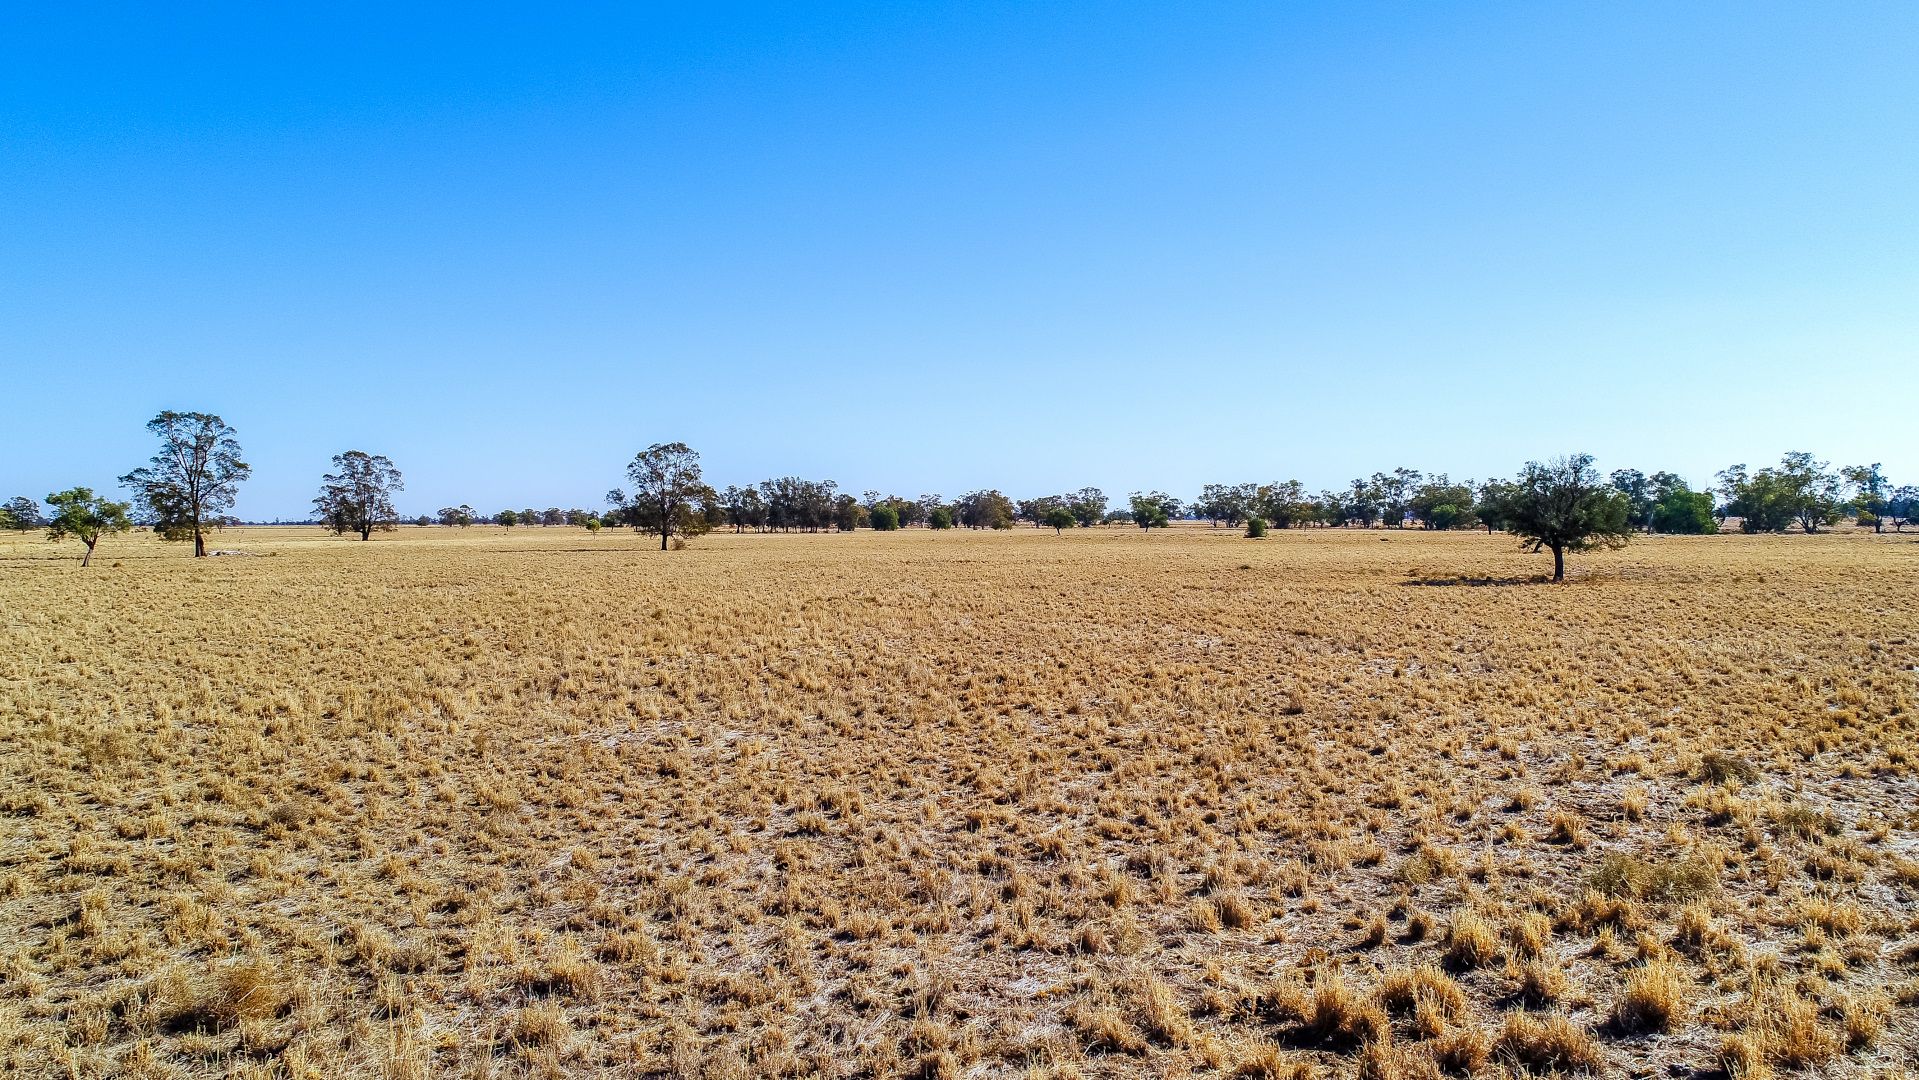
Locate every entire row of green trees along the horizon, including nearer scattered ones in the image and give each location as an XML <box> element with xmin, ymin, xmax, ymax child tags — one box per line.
<box><xmin>18</xmin><ymin>411</ymin><xmax>1919</xmax><ymax>579</ymax></box>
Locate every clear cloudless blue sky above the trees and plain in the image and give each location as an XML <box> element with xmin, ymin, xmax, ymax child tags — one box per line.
<box><xmin>0</xmin><ymin>0</ymin><xmax>1919</xmax><ymax>518</ymax></box>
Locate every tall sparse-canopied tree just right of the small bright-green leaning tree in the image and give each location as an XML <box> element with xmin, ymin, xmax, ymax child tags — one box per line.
<box><xmin>121</xmin><ymin>409</ymin><xmax>253</xmax><ymax>558</ymax></box>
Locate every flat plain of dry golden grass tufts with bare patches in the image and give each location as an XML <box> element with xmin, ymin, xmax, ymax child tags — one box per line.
<box><xmin>0</xmin><ymin>528</ymin><xmax>1919</xmax><ymax>1080</ymax></box>
